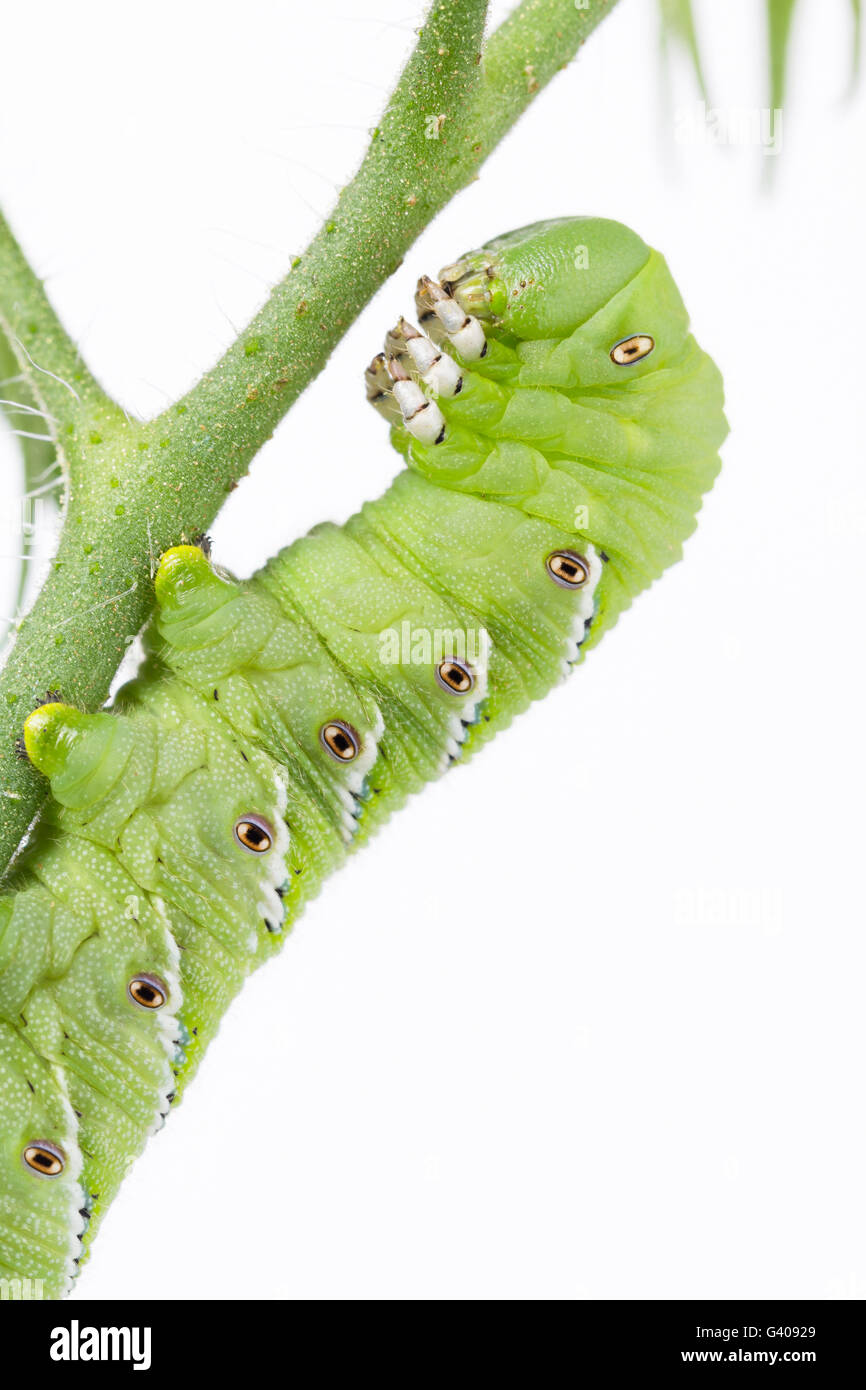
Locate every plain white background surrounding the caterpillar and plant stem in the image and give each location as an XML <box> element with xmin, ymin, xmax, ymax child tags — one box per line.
<box><xmin>0</xmin><ymin>0</ymin><xmax>866</xmax><ymax>1300</ymax></box>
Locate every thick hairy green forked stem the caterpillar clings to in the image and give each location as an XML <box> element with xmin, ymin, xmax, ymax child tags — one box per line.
<box><xmin>0</xmin><ymin>0</ymin><xmax>616</xmax><ymax>869</ymax></box>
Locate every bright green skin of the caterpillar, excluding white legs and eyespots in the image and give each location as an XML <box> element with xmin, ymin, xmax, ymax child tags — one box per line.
<box><xmin>0</xmin><ymin>218</ymin><xmax>727</xmax><ymax>1298</ymax></box>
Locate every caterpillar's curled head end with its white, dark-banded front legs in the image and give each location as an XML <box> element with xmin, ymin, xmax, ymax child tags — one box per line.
<box><xmin>367</xmin><ymin>217</ymin><xmax>727</xmax><ymax>641</ymax></box>
